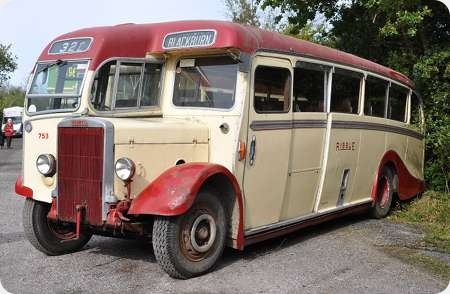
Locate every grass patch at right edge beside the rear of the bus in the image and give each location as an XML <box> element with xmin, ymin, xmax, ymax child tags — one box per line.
<box><xmin>388</xmin><ymin>191</ymin><xmax>450</xmax><ymax>254</ymax></box>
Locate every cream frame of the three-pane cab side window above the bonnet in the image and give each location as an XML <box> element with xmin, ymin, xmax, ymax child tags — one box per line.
<box><xmin>88</xmin><ymin>58</ymin><xmax>166</xmax><ymax>114</ymax></box>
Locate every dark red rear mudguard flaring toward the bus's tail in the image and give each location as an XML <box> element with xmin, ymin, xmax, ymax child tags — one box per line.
<box><xmin>372</xmin><ymin>150</ymin><xmax>425</xmax><ymax>201</ymax></box>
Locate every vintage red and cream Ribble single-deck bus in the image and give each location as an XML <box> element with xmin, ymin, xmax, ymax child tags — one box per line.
<box><xmin>15</xmin><ymin>21</ymin><xmax>424</xmax><ymax>278</ymax></box>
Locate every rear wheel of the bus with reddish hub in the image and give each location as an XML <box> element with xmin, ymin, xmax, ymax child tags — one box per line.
<box><xmin>371</xmin><ymin>166</ymin><xmax>394</xmax><ymax>218</ymax></box>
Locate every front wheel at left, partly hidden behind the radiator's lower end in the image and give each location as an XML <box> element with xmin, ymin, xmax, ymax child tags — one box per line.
<box><xmin>23</xmin><ymin>199</ymin><xmax>92</xmax><ymax>255</ymax></box>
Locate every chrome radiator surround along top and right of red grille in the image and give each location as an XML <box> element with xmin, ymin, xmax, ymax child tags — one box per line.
<box><xmin>57</xmin><ymin>117</ymin><xmax>114</xmax><ymax>221</ymax></box>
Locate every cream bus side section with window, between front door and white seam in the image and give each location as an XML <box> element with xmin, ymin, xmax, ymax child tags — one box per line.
<box><xmin>281</xmin><ymin>61</ymin><xmax>330</xmax><ymax>220</ymax></box>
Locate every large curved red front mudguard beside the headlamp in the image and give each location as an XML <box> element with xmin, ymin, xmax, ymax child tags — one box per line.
<box><xmin>128</xmin><ymin>163</ymin><xmax>244</xmax><ymax>249</ymax></box>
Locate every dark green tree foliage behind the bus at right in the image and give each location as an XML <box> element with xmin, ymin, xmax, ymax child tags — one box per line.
<box><xmin>260</xmin><ymin>0</ymin><xmax>450</xmax><ymax>191</ymax></box>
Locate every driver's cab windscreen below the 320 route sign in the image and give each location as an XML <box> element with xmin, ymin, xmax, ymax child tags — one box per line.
<box><xmin>27</xmin><ymin>60</ymin><xmax>88</xmax><ymax>113</ymax></box>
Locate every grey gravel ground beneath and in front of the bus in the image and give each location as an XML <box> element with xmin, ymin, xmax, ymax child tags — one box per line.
<box><xmin>0</xmin><ymin>140</ymin><xmax>449</xmax><ymax>294</ymax></box>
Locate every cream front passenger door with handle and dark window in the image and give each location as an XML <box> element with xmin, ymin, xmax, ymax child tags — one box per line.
<box><xmin>243</xmin><ymin>57</ymin><xmax>292</xmax><ymax>228</ymax></box>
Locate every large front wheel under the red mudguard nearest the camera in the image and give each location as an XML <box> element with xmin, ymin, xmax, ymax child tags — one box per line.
<box><xmin>152</xmin><ymin>192</ymin><xmax>227</xmax><ymax>279</ymax></box>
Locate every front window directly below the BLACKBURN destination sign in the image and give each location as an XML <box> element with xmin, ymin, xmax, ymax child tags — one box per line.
<box><xmin>173</xmin><ymin>56</ymin><xmax>238</xmax><ymax>109</ymax></box>
